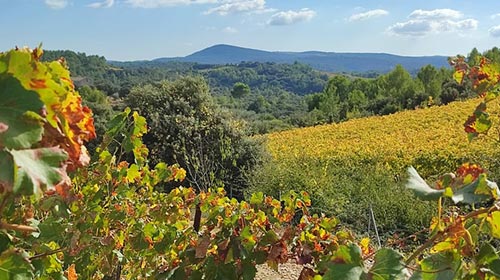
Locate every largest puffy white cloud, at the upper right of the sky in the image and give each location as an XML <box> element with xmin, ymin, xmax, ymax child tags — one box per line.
<box><xmin>387</xmin><ymin>9</ymin><xmax>479</xmax><ymax>36</ymax></box>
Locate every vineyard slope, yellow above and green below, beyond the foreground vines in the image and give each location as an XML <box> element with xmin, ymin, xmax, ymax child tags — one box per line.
<box><xmin>251</xmin><ymin>99</ymin><xmax>500</xmax><ymax>236</ymax></box>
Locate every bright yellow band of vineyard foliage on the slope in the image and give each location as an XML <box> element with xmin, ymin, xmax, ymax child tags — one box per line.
<box><xmin>267</xmin><ymin>99</ymin><xmax>500</xmax><ymax>175</ymax></box>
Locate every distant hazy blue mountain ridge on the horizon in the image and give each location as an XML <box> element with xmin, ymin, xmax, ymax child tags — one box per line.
<box><xmin>154</xmin><ymin>45</ymin><xmax>448</xmax><ymax>73</ymax></box>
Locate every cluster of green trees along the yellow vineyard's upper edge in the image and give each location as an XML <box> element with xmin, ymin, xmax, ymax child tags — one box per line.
<box><xmin>306</xmin><ymin>65</ymin><xmax>454</xmax><ymax>123</ymax></box>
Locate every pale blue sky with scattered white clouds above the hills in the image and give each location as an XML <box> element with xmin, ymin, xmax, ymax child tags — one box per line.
<box><xmin>0</xmin><ymin>0</ymin><xmax>500</xmax><ymax>60</ymax></box>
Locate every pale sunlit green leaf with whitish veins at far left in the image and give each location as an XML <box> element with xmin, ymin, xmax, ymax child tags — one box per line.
<box><xmin>10</xmin><ymin>147</ymin><xmax>67</xmax><ymax>195</ymax></box>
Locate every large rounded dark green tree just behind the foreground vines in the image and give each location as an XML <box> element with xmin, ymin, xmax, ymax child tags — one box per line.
<box><xmin>126</xmin><ymin>77</ymin><xmax>260</xmax><ymax>198</ymax></box>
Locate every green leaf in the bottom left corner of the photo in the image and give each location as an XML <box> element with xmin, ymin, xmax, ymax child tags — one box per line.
<box><xmin>0</xmin><ymin>250</ymin><xmax>34</xmax><ymax>280</ymax></box>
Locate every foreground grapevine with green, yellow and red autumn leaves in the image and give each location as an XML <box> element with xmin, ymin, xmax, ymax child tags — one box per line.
<box><xmin>0</xmin><ymin>48</ymin><xmax>500</xmax><ymax>280</ymax></box>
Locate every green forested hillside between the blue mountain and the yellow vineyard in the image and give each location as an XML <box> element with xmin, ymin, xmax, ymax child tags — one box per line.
<box><xmin>44</xmin><ymin>48</ymin><xmax>500</xmax><ymax>134</ymax></box>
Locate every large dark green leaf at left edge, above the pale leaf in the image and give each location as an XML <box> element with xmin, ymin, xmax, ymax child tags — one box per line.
<box><xmin>0</xmin><ymin>76</ymin><xmax>43</xmax><ymax>149</ymax></box>
